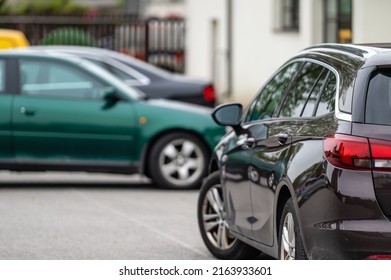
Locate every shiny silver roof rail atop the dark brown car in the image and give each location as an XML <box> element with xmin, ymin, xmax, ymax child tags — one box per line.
<box><xmin>304</xmin><ymin>44</ymin><xmax>380</xmax><ymax>58</ymax></box>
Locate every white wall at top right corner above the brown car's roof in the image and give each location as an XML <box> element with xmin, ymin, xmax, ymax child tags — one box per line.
<box><xmin>352</xmin><ymin>0</ymin><xmax>391</xmax><ymax>43</ymax></box>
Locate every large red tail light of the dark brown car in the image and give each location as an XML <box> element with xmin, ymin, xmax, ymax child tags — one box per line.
<box><xmin>323</xmin><ymin>134</ymin><xmax>391</xmax><ymax>171</ymax></box>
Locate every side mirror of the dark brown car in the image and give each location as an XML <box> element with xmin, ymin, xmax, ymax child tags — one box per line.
<box><xmin>212</xmin><ymin>103</ymin><xmax>243</xmax><ymax>132</ymax></box>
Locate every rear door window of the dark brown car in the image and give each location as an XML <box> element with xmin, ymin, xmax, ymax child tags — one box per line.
<box><xmin>279</xmin><ymin>62</ymin><xmax>328</xmax><ymax>117</ymax></box>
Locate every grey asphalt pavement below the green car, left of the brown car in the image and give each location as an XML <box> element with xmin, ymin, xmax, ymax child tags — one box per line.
<box><xmin>0</xmin><ymin>171</ymin><xmax>213</xmax><ymax>260</ymax></box>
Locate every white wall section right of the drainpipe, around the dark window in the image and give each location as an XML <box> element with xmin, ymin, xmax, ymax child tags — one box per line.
<box><xmin>233</xmin><ymin>0</ymin><xmax>321</xmax><ymax>103</ymax></box>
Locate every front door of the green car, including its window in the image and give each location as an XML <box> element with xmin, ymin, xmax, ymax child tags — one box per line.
<box><xmin>12</xmin><ymin>58</ymin><xmax>136</xmax><ymax>166</ymax></box>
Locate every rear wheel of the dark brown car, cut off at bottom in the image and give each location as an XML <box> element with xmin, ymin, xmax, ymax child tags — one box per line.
<box><xmin>278</xmin><ymin>198</ymin><xmax>307</xmax><ymax>260</ymax></box>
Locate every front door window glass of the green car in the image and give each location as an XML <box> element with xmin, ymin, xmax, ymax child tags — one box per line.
<box><xmin>20</xmin><ymin>60</ymin><xmax>105</xmax><ymax>99</ymax></box>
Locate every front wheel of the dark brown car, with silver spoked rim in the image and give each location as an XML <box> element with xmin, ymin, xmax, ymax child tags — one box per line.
<box><xmin>197</xmin><ymin>171</ymin><xmax>260</xmax><ymax>260</ymax></box>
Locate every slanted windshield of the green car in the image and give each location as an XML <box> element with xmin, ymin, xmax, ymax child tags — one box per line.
<box><xmin>81</xmin><ymin>59</ymin><xmax>146</xmax><ymax>100</ymax></box>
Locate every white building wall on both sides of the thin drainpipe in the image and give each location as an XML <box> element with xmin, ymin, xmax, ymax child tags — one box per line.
<box><xmin>186</xmin><ymin>0</ymin><xmax>322</xmax><ymax>104</ymax></box>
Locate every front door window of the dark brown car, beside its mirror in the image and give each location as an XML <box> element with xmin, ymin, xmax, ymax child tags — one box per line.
<box><xmin>244</xmin><ymin>62</ymin><xmax>302</xmax><ymax>122</ymax></box>
